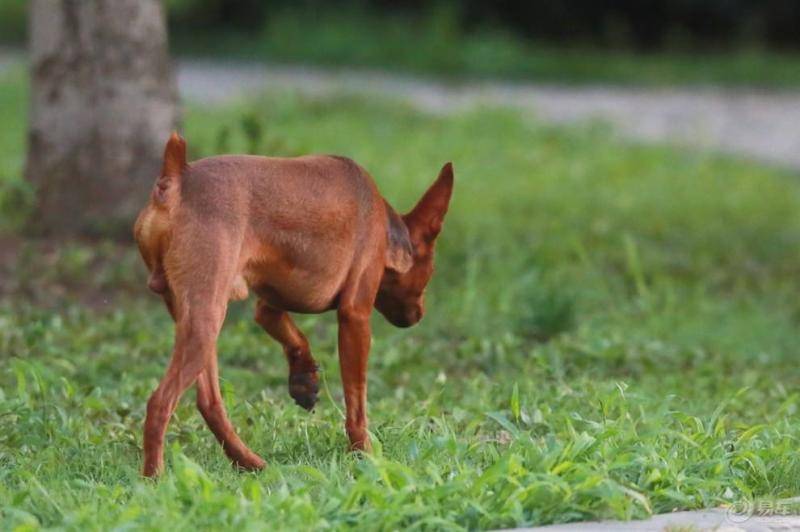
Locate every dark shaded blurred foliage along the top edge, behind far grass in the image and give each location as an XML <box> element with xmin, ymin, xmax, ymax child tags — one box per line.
<box><xmin>161</xmin><ymin>0</ymin><xmax>800</xmax><ymax>51</ymax></box>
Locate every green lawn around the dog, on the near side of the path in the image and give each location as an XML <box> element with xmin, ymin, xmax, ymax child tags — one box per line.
<box><xmin>0</xmin><ymin>68</ymin><xmax>800</xmax><ymax>530</ymax></box>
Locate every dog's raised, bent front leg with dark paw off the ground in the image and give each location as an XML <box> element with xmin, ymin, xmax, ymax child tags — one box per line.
<box><xmin>256</xmin><ymin>299</ymin><xmax>319</xmax><ymax>410</ymax></box>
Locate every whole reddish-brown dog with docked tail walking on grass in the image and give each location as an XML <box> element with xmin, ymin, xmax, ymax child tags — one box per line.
<box><xmin>134</xmin><ymin>134</ymin><xmax>453</xmax><ymax>476</ymax></box>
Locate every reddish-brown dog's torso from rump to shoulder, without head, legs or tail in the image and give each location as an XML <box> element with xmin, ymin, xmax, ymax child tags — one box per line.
<box><xmin>137</xmin><ymin>149</ymin><xmax>386</xmax><ymax>312</ymax></box>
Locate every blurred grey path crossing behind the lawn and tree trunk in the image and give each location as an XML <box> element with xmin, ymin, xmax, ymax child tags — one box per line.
<box><xmin>0</xmin><ymin>49</ymin><xmax>800</xmax><ymax>169</ymax></box>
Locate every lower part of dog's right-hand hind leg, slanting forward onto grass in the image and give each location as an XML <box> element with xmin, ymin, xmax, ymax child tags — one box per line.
<box><xmin>197</xmin><ymin>357</ymin><xmax>265</xmax><ymax>471</ymax></box>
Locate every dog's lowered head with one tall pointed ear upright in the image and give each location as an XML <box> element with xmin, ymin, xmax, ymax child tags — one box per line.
<box><xmin>375</xmin><ymin>163</ymin><xmax>453</xmax><ymax>327</ymax></box>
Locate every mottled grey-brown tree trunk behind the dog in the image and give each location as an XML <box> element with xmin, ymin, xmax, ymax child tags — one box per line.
<box><xmin>25</xmin><ymin>0</ymin><xmax>177</xmax><ymax>236</ymax></box>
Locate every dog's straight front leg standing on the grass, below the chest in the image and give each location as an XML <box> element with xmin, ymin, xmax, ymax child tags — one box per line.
<box><xmin>338</xmin><ymin>308</ymin><xmax>372</xmax><ymax>451</ymax></box>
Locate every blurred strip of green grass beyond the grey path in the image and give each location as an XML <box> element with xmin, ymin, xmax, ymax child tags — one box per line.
<box><xmin>172</xmin><ymin>9</ymin><xmax>800</xmax><ymax>87</ymax></box>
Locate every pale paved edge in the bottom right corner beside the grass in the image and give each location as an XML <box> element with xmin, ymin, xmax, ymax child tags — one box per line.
<box><xmin>516</xmin><ymin>510</ymin><xmax>800</xmax><ymax>532</ymax></box>
